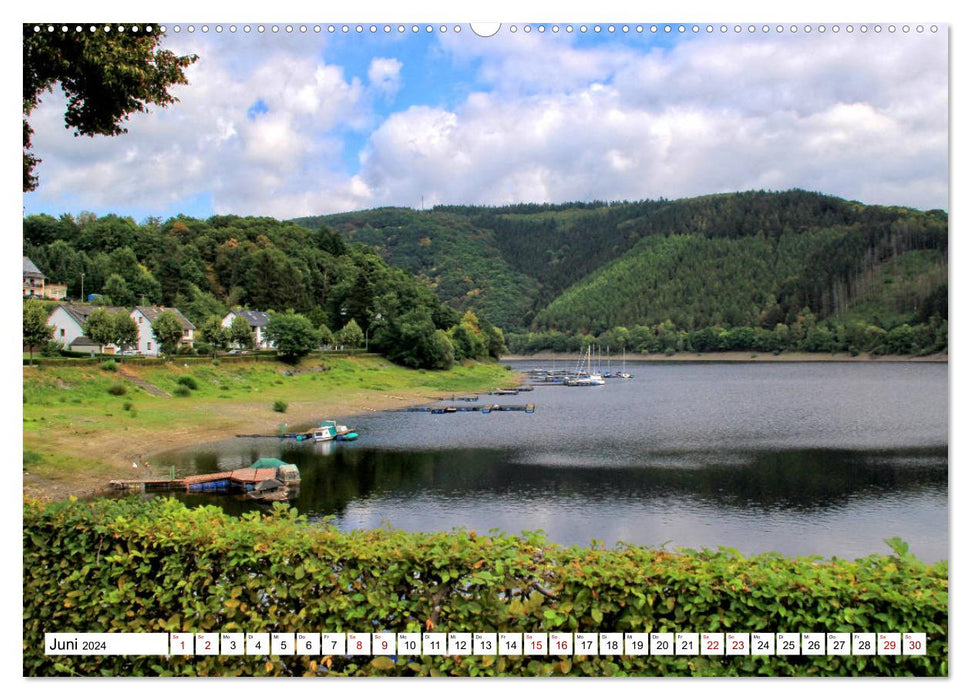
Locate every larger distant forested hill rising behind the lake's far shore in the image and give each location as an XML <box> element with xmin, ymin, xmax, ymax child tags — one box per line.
<box><xmin>296</xmin><ymin>190</ymin><xmax>948</xmax><ymax>349</ymax></box>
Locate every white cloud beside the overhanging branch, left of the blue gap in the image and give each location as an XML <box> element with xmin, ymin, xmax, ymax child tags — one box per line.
<box><xmin>25</xmin><ymin>35</ymin><xmax>373</xmax><ymax>217</ymax></box>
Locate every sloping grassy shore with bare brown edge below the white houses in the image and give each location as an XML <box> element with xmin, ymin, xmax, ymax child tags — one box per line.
<box><xmin>23</xmin><ymin>356</ymin><xmax>516</xmax><ymax>499</ymax></box>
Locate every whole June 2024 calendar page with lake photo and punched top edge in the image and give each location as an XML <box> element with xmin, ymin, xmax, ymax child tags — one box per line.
<box><xmin>21</xmin><ymin>0</ymin><xmax>952</xmax><ymax>680</ymax></box>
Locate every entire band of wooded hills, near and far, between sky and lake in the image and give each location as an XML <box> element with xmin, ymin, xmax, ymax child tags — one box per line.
<box><xmin>24</xmin><ymin>190</ymin><xmax>948</xmax><ymax>360</ymax></box>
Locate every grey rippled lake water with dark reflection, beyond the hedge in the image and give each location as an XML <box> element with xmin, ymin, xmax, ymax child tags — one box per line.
<box><xmin>156</xmin><ymin>363</ymin><xmax>948</xmax><ymax>561</ymax></box>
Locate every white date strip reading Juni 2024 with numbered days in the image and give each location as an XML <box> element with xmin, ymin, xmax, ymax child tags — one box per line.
<box><xmin>44</xmin><ymin>632</ymin><xmax>927</xmax><ymax>657</ymax></box>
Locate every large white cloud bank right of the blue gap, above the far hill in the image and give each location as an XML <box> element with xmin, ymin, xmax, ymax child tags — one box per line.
<box><xmin>361</xmin><ymin>35</ymin><xmax>947</xmax><ymax>208</ymax></box>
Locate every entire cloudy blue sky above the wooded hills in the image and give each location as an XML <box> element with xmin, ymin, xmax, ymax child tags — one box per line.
<box><xmin>24</xmin><ymin>22</ymin><xmax>949</xmax><ymax>221</ymax></box>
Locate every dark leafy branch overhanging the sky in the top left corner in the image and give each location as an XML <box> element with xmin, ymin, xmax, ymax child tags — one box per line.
<box><xmin>23</xmin><ymin>24</ymin><xmax>198</xmax><ymax>192</ymax></box>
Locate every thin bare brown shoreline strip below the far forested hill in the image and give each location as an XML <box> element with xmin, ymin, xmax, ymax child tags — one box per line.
<box><xmin>500</xmin><ymin>352</ymin><xmax>948</xmax><ymax>366</ymax></box>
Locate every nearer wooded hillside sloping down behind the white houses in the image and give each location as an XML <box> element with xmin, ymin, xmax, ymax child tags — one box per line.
<box><xmin>24</xmin><ymin>214</ymin><xmax>504</xmax><ymax>368</ymax></box>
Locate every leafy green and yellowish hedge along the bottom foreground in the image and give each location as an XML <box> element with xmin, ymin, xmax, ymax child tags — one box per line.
<box><xmin>23</xmin><ymin>498</ymin><xmax>948</xmax><ymax>677</ymax></box>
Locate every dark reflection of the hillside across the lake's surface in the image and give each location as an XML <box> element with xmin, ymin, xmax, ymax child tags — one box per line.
<box><xmin>156</xmin><ymin>445</ymin><xmax>948</xmax><ymax>516</ymax></box>
